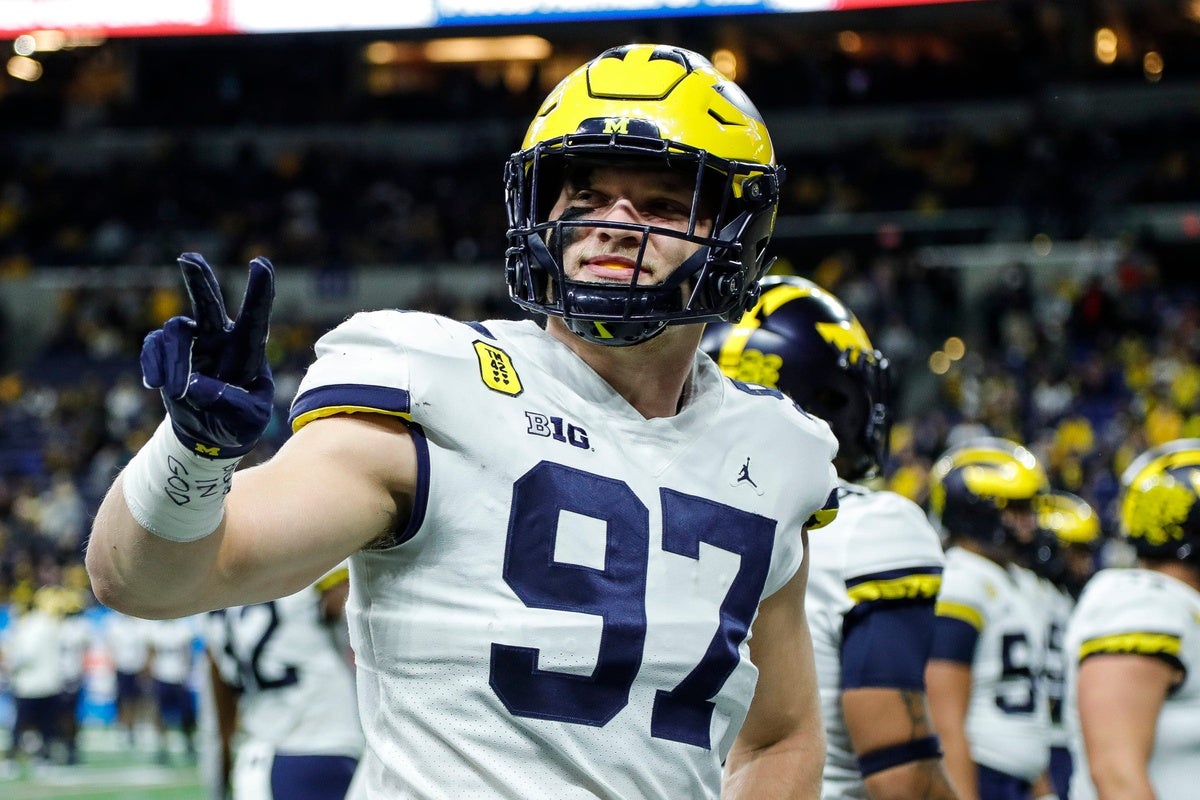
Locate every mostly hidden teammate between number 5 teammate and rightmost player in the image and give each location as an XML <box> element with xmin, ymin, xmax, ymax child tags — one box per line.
<box><xmin>1030</xmin><ymin>489</ymin><xmax>1102</xmax><ymax>799</ymax></box>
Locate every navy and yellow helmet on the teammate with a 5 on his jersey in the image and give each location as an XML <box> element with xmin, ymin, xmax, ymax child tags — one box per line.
<box><xmin>929</xmin><ymin>437</ymin><xmax>1049</xmax><ymax>547</ymax></box>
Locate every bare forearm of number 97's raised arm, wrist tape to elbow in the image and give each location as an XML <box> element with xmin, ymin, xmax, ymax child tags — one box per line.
<box><xmin>86</xmin><ymin>476</ymin><xmax>221</xmax><ymax>619</ymax></box>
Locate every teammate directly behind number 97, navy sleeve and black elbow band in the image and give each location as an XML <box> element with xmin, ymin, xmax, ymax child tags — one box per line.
<box><xmin>701</xmin><ymin>277</ymin><xmax>954</xmax><ymax>800</ymax></box>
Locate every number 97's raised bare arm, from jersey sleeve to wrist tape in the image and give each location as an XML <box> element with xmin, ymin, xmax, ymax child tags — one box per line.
<box><xmin>88</xmin><ymin>415</ymin><xmax>416</xmax><ymax>618</ymax></box>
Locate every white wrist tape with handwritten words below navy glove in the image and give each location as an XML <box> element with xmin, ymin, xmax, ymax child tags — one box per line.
<box><xmin>122</xmin><ymin>417</ymin><xmax>241</xmax><ymax>542</ymax></box>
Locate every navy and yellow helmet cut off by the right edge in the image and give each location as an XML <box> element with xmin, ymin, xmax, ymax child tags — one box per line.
<box><xmin>1121</xmin><ymin>439</ymin><xmax>1200</xmax><ymax>566</ymax></box>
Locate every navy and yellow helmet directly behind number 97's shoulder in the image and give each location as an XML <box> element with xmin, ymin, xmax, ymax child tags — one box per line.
<box><xmin>700</xmin><ymin>277</ymin><xmax>890</xmax><ymax>481</ymax></box>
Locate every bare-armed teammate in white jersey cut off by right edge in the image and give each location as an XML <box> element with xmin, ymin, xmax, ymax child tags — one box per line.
<box><xmin>1066</xmin><ymin>439</ymin><xmax>1200</xmax><ymax>800</ymax></box>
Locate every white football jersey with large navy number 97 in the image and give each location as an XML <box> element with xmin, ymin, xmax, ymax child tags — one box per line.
<box><xmin>292</xmin><ymin>312</ymin><xmax>836</xmax><ymax>800</ymax></box>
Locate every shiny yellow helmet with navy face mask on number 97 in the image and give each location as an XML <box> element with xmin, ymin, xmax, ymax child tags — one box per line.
<box><xmin>504</xmin><ymin>44</ymin><xmax>782</xmax><ymax>345</ymax></box>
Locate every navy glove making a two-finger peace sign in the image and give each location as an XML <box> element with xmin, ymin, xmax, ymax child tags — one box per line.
<box><xmin>142</xmin><ymin>253</ymin><xmax>275</xmax><ymax>458</ymax></box>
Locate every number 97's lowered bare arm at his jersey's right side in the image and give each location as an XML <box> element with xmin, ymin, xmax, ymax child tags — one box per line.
<box><xmin>721</xmin><ymin>533</ymin><xmax>824</xmax><ymax>800</ymax></box>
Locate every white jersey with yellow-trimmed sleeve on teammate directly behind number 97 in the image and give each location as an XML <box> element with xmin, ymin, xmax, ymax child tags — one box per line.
<box><xmin>804</xmin><ymin>483</ymin><xmax>946</xmax><ymax>800</ymax></box>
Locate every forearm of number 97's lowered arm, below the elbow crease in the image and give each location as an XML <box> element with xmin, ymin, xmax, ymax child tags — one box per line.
<box><xmin>721</xmin><ymin>727</ymin><xmax>824</xmax><ymax>800</ymax></box>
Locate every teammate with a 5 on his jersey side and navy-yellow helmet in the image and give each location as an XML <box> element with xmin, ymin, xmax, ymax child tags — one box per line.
<box><xmin>926</xmin><ymin>438</ymin><xmax>1050</xmax><ymax>800</ymax></box>
